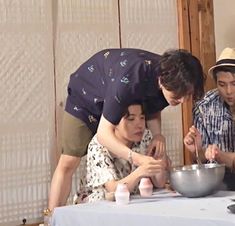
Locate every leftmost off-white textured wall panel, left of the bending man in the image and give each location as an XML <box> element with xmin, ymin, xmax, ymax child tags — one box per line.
<box><xmin>0</xmin><ymin>0</ymin><xmax>55</xmax><ymax>226</ymax></box>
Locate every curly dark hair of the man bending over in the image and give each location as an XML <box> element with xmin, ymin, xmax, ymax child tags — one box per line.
<box><xmin>157</xmin><ymin>49</ymin><xmax>206</xmax><ymax>101</ymax></box>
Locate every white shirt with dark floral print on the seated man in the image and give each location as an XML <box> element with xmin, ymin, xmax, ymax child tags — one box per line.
<box><xmin>74</xmin><ymin>130</ymin><xmax>152</xmax><ymax>203</ymax></box>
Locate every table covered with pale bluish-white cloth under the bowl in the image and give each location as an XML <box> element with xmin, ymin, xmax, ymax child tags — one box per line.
<box><xmin>52</xmin><ymin>190</ymin><xmax>235</xmax><ymax>226</ymax></box>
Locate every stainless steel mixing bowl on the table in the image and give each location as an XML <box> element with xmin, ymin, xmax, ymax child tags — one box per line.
<box><xmin>170</xmin><ymin>163</ymin><xmax>225</xmax><ymax>198</ymax></box>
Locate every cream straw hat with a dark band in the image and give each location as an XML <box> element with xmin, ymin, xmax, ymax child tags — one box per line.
<box><xmin>208</xmin><ymin>47</ymin><xmax>235</xmax><ymax>76</ymax></box>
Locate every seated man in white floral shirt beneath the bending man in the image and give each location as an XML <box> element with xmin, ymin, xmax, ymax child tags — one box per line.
<box><xmin>74</xmin><ymin>103</ymin><xmax>170</xmax><ymax>203</ymax></box>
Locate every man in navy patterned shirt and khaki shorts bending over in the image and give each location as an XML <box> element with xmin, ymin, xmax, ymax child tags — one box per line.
<box><xmin>49</xmin><ymin>49</ymin><xmax>205</xmax><ymax>210</ymax></box>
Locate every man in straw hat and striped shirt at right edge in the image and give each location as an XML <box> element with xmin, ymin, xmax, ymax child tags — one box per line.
<box><xmin>184</xmin><ymin>48</ymin><xmax>235</xmax><ymax>190</ymax></box>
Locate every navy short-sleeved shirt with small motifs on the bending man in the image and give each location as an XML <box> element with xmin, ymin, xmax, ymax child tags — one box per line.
<box><xmin>65</xmin><ymin>49</ymin><xmax>168</xmax><ymax>133</ymax></box>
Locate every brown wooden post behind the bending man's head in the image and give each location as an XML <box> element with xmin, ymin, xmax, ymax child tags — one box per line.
<box><xmin>177</xmin><ymin>0</ymin><xmax>215</xmax><ymax>164</ymax></box>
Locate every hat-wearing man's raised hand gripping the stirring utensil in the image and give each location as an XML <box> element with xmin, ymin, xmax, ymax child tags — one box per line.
<box><xmin>184</xmin><ymin>126</ymin><xmax>202</xmax><ymax>153</ymax></box>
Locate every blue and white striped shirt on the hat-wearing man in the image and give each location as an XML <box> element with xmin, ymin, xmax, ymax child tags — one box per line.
<box><xmin>193</xmin><ymin>89</ymin><xmax>235</xmax><ymax>152</ymax></box>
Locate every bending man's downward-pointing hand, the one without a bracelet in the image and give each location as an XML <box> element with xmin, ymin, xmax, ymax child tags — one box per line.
<box><xmin>147</xmin><ymin>134</ymin><xmax>166</xmax><ymax>159</ymax></box>
